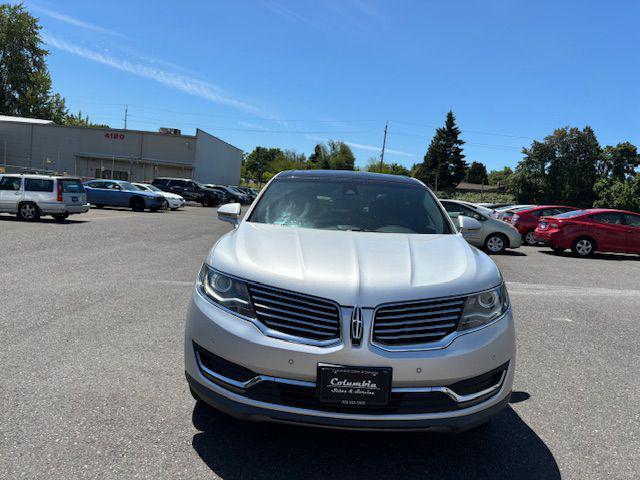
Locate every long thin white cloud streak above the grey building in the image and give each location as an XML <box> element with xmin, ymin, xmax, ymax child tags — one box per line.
<box><xmin>43</xmin><ymin>32</ymin><xmax>272</xmax><ymax>117</ymax></box>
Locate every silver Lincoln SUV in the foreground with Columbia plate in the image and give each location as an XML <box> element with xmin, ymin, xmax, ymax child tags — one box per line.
<box><xmin>184</xmin><ymin>170</ymin><xmax>515</xmax><ymax>431</ymax></box>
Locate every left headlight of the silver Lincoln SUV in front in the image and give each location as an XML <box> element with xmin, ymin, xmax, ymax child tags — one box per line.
<box><xmin>198</xmin><ymin>265</ymin><xmax>256</xmax><ymax>318</ymax></box>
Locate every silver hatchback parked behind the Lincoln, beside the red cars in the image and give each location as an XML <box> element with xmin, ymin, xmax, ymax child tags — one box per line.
<box><xmin>440</xmin><ymin>200</ymin><xmax>522</xmax><ymax>254</ymax></box>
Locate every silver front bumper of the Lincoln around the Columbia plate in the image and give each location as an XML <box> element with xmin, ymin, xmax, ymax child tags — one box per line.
<box><xmin>185</xmin><ymin>286</ymin><xmax>515</xmax><ymax>431</ymax></box>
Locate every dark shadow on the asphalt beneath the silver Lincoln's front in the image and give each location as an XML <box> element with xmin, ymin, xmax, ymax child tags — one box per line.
<box><xmin>192</xmin><ymin>392</ymin><xmax>560</xmax><ymax>480</ymax></box>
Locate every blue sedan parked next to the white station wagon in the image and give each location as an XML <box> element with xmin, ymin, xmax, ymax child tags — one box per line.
<box><xmin>83</xmin><ymin>180</ymin><xmax>168</xmax><ymax>212</ymax></box>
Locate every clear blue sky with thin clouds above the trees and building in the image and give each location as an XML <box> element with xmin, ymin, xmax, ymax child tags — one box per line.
<box><xmin>18</xmin><ymin>0</ymin><xmax>640</xmax><ymax>168</ymax></box>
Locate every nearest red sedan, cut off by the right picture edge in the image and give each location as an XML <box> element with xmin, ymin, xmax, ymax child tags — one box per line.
<box><xmin>535</xmin><ymin>208</ymin><xmax>640</xmax><ymax>257</ymax></box>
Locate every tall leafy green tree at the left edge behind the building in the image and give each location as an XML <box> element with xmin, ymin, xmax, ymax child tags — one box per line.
<box><xmin>0</xmin><ymin>3</ymin><xmax>67</xmax><ymax>123</ymax></box>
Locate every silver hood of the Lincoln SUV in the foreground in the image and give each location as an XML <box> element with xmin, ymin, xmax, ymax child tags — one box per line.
<box><xmin>206</xmin><ymin>222</ymin><xmax>502</xmax><ymax>307</ymax></box>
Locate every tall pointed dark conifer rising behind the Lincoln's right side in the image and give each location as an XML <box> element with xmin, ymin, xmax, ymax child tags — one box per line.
<box><xmin>415</xmin><ymin>111</ymin><xmax>467</xmax><ymax>189</ymax></box>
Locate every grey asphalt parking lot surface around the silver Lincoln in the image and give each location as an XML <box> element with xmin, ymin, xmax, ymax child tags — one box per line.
<box><xmin>0</xmin><ymin>207</ymin><xmax>640</xmax><ymax>479</ymax></box>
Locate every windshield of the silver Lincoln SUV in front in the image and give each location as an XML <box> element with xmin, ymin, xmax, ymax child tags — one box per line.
<box><xmin>248</xmin><ymin>178</ymin><xmax>451</xmax><ymax>234</ymax></box>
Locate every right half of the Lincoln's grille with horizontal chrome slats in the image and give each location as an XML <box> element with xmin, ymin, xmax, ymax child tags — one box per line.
<box><xmin>373</xmin><ymin>297</ymin><xmax>466</xmax><ymax>346</ymax></box>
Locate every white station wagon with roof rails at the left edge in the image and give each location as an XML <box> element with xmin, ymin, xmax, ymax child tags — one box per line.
<box><xmin>0</xmin><ymin>174</ymin><xmax>90</xmax><ymax>221</ymax></box>
